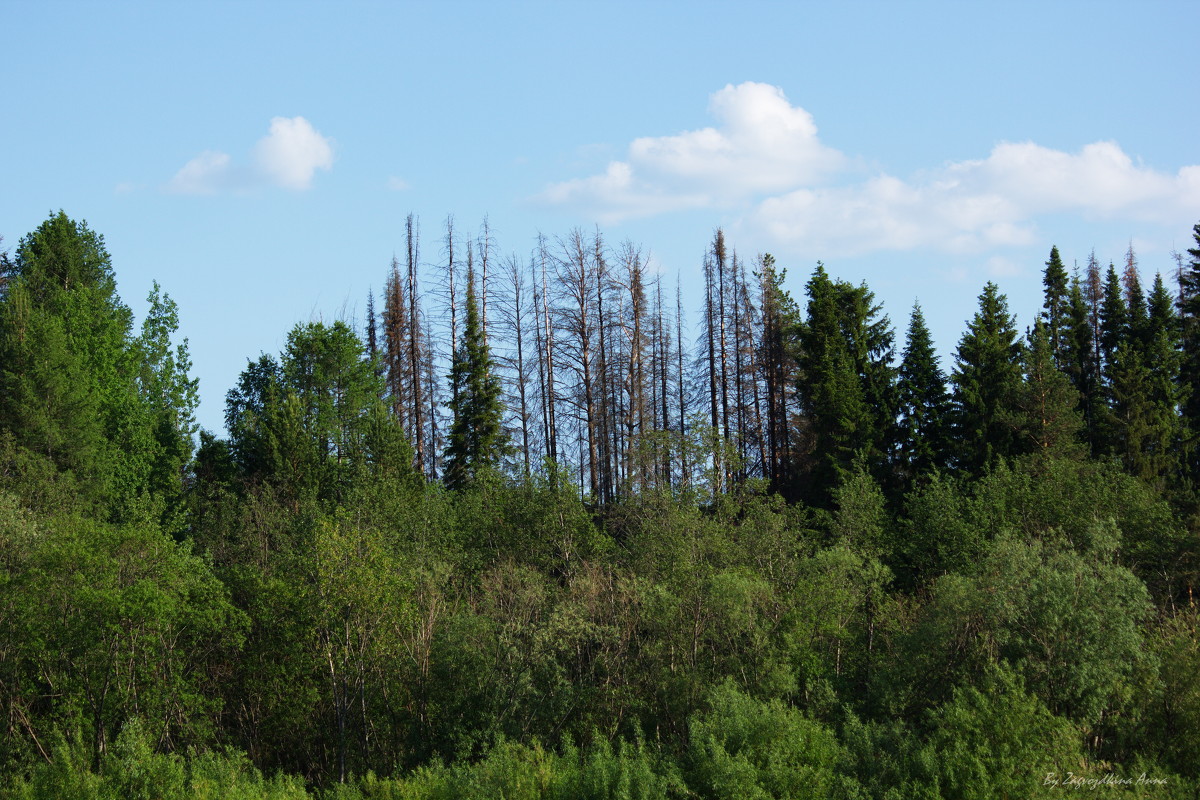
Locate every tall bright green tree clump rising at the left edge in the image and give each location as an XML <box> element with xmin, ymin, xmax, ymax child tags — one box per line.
<box><xmin>0</xmin><ymin>211</ymin><xmax>196</xmax><ymax>531</ymax></box>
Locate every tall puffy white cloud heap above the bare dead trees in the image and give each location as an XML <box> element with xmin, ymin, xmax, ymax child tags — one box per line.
<box><xmin>542</xmin><ymin>83</ymin><xmax>846</xmax><ymax>221</ymax></box>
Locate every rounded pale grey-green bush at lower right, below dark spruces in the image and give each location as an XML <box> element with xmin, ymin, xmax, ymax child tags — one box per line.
<box><xmin>895</xmin><ymin>525</ymin><xmax>1150</xmax><ymax>726</ymax></box>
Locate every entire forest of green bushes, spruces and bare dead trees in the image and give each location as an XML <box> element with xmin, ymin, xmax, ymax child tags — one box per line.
<box><xmin>0</xmin><ymin>211</ymin><xmax>1200</xmax><ymax>800</ymax></box>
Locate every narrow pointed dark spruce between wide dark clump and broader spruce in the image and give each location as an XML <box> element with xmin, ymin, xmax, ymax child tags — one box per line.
<box><xmin>896</xmin><ymin>303</ymin><xmax>950</xmax><ymax>486</ymax></box>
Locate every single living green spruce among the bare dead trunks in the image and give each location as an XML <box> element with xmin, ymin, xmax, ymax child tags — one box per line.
<box><xmin>445</xmin><ymin>260</ymin><xmax>509</xmax><ymax>489</ymax></box>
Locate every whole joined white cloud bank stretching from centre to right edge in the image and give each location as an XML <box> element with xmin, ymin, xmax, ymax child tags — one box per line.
<box><xmin>541</xmin><ymin>83</ymin><xmax>1200</xmax><ymax>255</ymax></box>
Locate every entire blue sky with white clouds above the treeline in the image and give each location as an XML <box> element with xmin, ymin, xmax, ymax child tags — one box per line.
<box><xmin>0</xmin><ymin>0</ymin><xmax>1200</xmax><ymax>429</ymax></box>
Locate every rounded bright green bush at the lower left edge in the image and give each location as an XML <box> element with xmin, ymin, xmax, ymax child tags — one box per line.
<box><xmin>0</xmin><ymin>510</ymin><xmax>245</xmax><ymax>763</ymax></box>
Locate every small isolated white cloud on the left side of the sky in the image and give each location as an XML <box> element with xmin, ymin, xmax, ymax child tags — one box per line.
<box><xmin>167</xmin><ymin>116</ymin><xmax>334</xmax><ymax>194</ymax></box>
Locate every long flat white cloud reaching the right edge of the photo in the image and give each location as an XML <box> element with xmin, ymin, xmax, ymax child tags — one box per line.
<box><xmin>745</xmin><ymin>142</ymin><xmax>1200</xmax><ymax>254</ymax></box>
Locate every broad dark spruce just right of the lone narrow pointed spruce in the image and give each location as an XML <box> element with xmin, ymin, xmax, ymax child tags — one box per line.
<box><xmin>952</xmin><ymin>282</ymin><xmax>1022</xmax><ymax>473</ymax></box>
